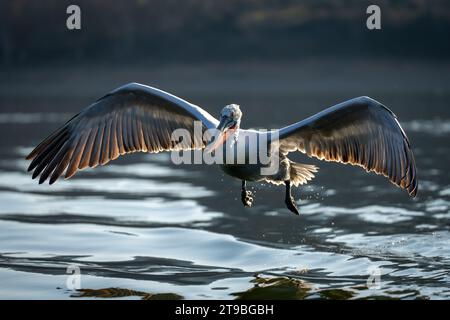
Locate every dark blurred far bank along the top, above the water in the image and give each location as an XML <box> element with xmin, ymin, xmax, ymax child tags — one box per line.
<box><xmin>0</xmin><ymin>0</ymin><xmax>450</xmax><ymax>66</ymax></box>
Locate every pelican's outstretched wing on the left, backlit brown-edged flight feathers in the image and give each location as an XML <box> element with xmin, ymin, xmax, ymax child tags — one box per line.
<box><xmin>27</xmin><ymin>83</ymin><xmax>218</xmax><ymax>184</ymax></box>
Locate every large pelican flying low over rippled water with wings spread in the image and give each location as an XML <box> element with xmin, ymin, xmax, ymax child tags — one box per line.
<box><xmin>26</xmin><ymin>83</ymin><xmax>418</xmax><ymax>214</ymax></box>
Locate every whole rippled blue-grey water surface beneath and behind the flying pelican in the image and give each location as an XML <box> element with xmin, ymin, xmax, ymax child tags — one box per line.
<box><xmin>0</xmin><ymin>62</ymin><xmax>450</xmax><ymax>299</ymax></box>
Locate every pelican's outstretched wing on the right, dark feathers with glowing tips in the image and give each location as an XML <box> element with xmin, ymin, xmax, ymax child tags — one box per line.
<box><xmin>279</xmin><ymin>97</ymin><xmax>418</xmax><ymax>197</ymax></box>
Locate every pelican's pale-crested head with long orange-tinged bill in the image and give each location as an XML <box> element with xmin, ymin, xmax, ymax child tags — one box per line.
<box><xmin>206</xmin><ymin>104</ymin><xmax>242</xmax><ymax>152</ymax></box>
